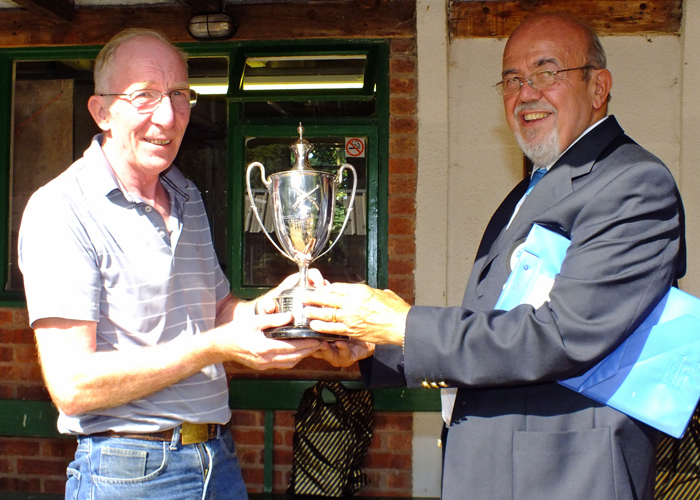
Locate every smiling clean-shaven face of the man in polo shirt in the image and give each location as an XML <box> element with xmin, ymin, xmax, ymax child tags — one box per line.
<box><xmin>88</xmin><ymin>36</ymin><xmax>190</xmax><ymax>181</ymax></box>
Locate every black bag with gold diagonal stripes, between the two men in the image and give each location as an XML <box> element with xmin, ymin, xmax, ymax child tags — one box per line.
<box><xmin>288</xmin><ymin>381</ymin><xmax>372</xmax><ymax>497</ymax></box>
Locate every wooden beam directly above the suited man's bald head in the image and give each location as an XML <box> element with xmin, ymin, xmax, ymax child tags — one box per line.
<box><xmin>449</xmin><ymin>0</ymin><xmax>683</xmax><ymax>38</ymax></box>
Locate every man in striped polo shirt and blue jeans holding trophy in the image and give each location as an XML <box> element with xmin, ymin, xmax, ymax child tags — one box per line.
<box><xmin>19</xmin><ymin>30</ymin><xmax>319</xmax><ymax>500</ymax></box>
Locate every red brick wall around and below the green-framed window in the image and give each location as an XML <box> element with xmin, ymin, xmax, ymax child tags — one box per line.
<box><xmin>0</xmin><ymin>34</ymin><xmax>417</xmax><ymax>496</ymax></box>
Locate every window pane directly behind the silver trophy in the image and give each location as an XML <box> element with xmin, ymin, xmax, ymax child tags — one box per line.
<box><xmin>242</xmin><ymin>137</ymin><xmax>367</xmax><ymax>286</ymax></box>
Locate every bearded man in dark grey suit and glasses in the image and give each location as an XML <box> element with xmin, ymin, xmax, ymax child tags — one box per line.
<box><xmin>307</xmin><ymin>11</ymin><xmax>685</xmax><ymax>500</ymax></box>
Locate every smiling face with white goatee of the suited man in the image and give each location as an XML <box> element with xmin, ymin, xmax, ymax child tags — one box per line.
<box><xmin>502</xmin><ymin>16</ymin><xmax>612</xmax><ymax>166</ymax></box>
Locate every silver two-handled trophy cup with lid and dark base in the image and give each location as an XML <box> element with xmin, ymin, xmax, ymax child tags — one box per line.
<box><xmin>246</xmin><ymin>123</ymin><xmax>357</xmax><ymax>340</ymax></box>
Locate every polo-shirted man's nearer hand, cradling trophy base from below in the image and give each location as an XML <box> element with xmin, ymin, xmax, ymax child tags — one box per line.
<box><xmin>217</xmin><ymin>313</ymin><xmax>322</xmax><ymax>370</ymax></box>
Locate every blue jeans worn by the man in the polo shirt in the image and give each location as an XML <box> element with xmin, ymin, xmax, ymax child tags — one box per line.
<box><xmin>66</xmin><ymin>427</ymin><xmax>248</xmax><ymax>500</ymax></box>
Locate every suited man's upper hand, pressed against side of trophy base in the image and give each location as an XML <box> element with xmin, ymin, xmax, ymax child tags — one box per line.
<box><xmin>304</xmin><ymin>283</ymin><xmax>411</xmax><ymax>345</ymax></box>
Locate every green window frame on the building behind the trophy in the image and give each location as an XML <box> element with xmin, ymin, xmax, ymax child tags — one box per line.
<box><xmin>0</xmin><ymin>40</ymin><xmax>390</xmax><ymax>307</ymax></box>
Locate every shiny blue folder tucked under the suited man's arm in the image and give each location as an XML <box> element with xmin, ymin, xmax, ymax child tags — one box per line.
<box><xmin>496</xmin><ymin>225</ymin><xmax>700</xmax><ymax>438</ymax></box>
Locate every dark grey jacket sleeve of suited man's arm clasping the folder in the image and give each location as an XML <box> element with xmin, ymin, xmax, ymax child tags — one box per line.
<box><xmin>404</xmin><ymin>156</ymin><xmax>682</xmax><ymax>388</ymax></box>
